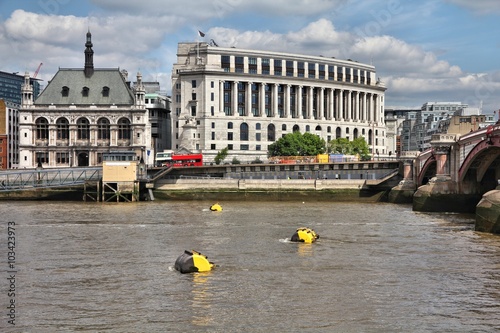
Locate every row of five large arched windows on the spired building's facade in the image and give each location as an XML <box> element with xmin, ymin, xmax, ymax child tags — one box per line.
<box><xmin>35</xmin><ymin>117</ymin><xmax>131</xmax><ymax>140</ymax></box>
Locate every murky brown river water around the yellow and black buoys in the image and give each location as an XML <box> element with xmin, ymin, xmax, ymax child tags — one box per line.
<box><xmin>0</xmin><ymin>201</ymin><xmax>500</xmax><ymax>332</ymax></box>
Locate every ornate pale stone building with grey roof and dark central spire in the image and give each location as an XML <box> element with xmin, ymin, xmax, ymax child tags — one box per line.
<box><xmin>19</xmin><ymin>32</ymin><xmax>153</xmax><ymax>168</ymax></box>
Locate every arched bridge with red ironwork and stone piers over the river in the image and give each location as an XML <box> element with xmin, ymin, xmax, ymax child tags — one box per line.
<box><xmin>394</xmin><ymin>123</ymin><xmax>500</xmax><ymax>212</ymax></box>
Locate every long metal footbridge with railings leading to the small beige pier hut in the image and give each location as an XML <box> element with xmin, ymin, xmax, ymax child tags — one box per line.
<box><xmin>0</xmin><ymin>167</ymin><xmax>102</xmax><ymax>192</ymax></box>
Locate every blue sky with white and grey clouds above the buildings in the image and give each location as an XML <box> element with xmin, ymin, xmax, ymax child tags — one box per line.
<box><xmin>0</xmin><ymin>0</ymin><xmax>500</xmax><ymax>114</ymax></box>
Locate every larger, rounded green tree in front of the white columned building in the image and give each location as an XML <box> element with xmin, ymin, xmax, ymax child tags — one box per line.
<box><xmin>267</xmin><ymin>131</ymin><xmax>325</xmax><ymax>157</ymax></box>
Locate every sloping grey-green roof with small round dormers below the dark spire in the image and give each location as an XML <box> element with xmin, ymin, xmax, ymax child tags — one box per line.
<box><xmin>34</xmin><ymin>68</ymin><xmax>134</xmax><ymax>105</ymax></box>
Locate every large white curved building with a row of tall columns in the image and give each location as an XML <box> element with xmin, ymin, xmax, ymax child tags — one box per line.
<box><xmin>172</xmin><ymin>43</ymin><xmax>386</xmax><ymax>162</ymax></box>
